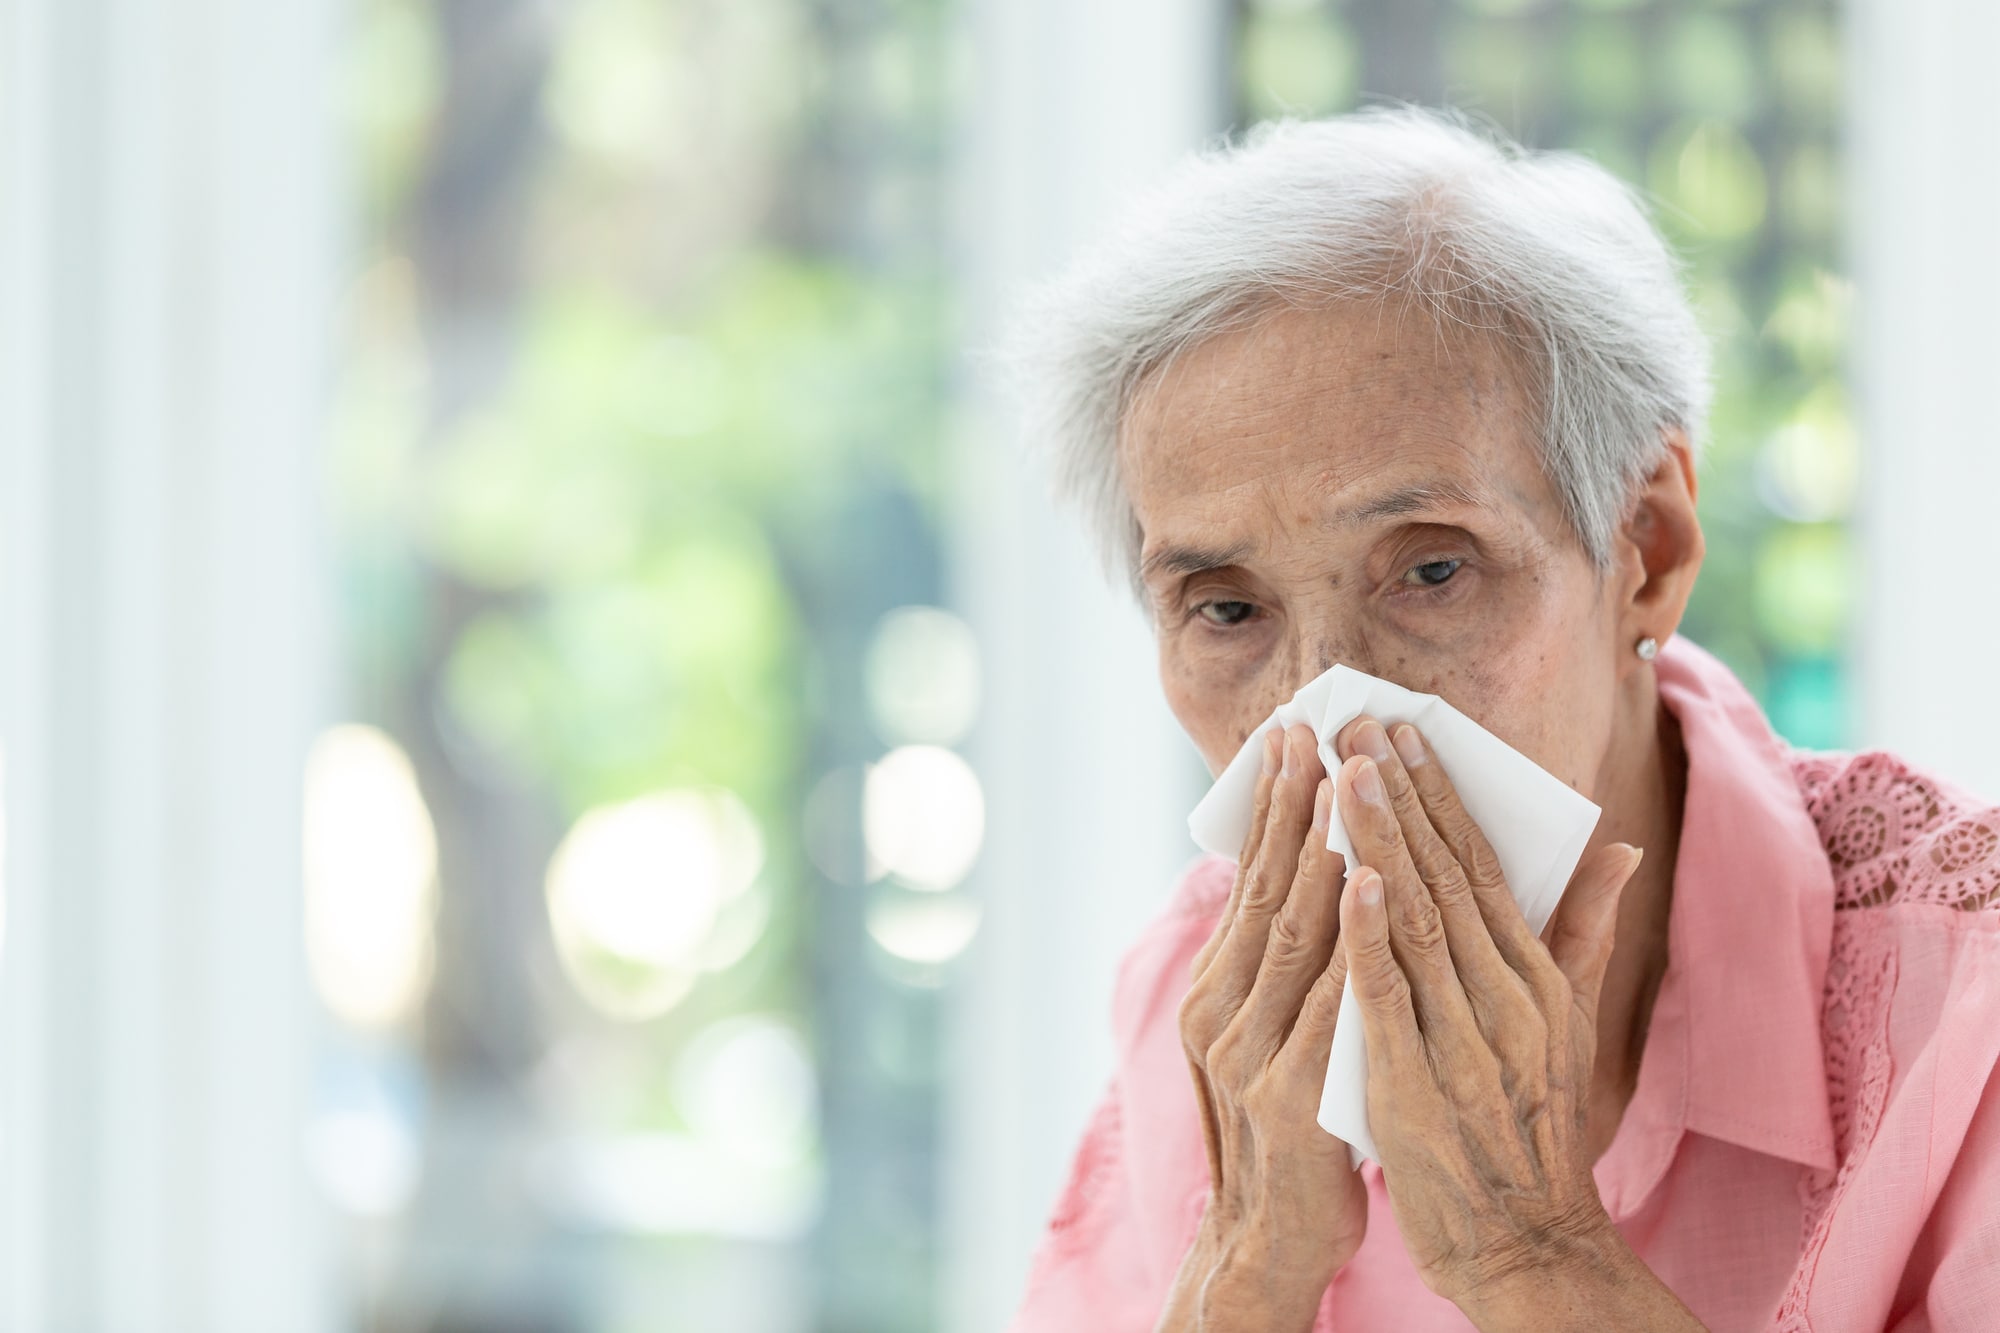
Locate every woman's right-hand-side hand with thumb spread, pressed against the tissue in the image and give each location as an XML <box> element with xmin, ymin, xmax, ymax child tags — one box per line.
<box><xmin>1336</xmin><ymin>719</ymin><xmax>1700</xmax><ymax>1329</ymax></box>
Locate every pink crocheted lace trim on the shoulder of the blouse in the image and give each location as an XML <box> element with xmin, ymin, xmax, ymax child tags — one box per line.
<box><xmin>1792</xmin><ymin>751</ymin><xmax>2000</xmax><ymax>911</ymax></box>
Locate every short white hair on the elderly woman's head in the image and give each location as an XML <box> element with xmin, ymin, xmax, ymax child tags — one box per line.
<box><xmin>1002</xmin><ymin>106</ymin><xmax>1710</xmax><ymax>602</ymax></box>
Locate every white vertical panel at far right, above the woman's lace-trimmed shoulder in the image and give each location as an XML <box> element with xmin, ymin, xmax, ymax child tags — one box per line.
<box><xmin>1846</xmin><ymin>0</ymin><xmax>2000</xmax><ymax>801</ymax></box>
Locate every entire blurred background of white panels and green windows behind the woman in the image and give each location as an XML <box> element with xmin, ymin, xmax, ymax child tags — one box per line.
<box><xmin>0</xmin><ymin>0</ymin><xmax>2000</xmax><ymax>1333</ymax></box>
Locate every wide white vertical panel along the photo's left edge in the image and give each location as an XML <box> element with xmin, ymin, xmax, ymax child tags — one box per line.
<box><xmin>0</xmin><ymin>0</ymin><xmax>340</xmax><ymax>1333</ymax></box>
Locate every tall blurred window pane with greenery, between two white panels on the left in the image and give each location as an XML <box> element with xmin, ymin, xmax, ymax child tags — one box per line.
<box><xmin>326</xmin><ymin>0</ymin><xmax>960</xmax><ymax>1333</ymax></box>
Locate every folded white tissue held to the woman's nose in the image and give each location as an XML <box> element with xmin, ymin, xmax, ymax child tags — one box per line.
<box><xmin>1188</xmin><ymin>667</ymin><xmax>1598</xmax><ymax>1167</ymax></box>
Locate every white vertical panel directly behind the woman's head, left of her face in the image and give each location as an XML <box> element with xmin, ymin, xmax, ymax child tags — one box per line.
<box><xmin>946</xmin><ymin>0</ymin><xmax>1228</xmax><ymax>1333</ymax></box>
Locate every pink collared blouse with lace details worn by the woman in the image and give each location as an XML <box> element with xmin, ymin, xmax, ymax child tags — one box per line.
<box><xmin>1010</xmin><ymin>638</ymin><xmax>2000</xmax><ymax>1333</ymax></box>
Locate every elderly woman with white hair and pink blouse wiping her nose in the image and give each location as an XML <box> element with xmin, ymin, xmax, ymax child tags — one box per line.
<box><xmin>1014</xmin><ymin>110</ymin><xmax>2000</xmax><ymax>1333</ymax></box>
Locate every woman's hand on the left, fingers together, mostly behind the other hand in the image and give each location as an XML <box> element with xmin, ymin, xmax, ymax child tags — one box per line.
<box><xmin>1162</xmin><ymin>725</ymin><xmax>1368</xmax><ymax>1329</ymax></box>
